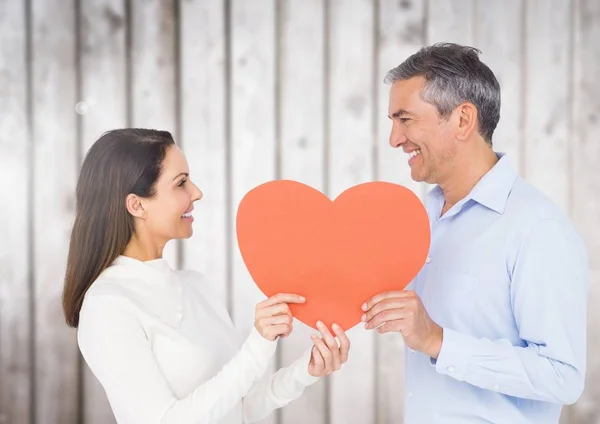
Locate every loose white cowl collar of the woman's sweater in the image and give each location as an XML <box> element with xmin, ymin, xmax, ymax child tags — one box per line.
<box><xmin>103</xmin><ymin>255</ymin><xmax>183</xmax><ymax>328</ymax></box>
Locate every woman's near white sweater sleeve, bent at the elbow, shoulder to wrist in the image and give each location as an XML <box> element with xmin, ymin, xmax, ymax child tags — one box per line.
<box><xmin>78</xmin><ymin>295</ymin><xmax>280</xmax><ymax>424</ymax></box>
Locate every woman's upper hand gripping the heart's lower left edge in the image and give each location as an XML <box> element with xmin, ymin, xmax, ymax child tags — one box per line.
<box><xmin>254</xmin><ymin>293</ymin><xmax>305</xmax><ymax>341</ymax></box>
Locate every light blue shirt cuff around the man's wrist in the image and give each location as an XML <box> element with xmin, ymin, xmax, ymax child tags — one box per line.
<box><xmin>431</xmin><ymin>328</ymin><xmax>472</xmax><ymax>381</ymax></box>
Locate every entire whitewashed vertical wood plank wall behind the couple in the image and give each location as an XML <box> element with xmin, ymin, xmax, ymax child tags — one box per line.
<box><xmin>0</xmin><ymin>0</ymin><xmax>600</xmax><ymax>424</ymax></box>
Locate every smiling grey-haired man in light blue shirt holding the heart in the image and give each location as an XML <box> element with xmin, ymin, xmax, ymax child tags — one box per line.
<box><xmin>363</xmin><ymin>44</ymin><xmax>588</xmax><ymax>424</ymax></box>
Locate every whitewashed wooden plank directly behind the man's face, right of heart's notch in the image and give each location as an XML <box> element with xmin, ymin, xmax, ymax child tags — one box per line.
<box><xmin>376</xmin><ymin>0</ymin><xmax>426</xmax><ymax>424</ymax></box>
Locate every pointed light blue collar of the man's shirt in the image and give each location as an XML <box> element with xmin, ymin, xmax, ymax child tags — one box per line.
<box><xmin>427</xmin><ymin>153</ymin><xmax>518</xmax><ymax>214</ymax></box>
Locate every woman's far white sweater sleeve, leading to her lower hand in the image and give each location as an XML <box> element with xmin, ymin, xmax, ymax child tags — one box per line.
<box><xmin>243</xmin><ymin>347</ymin><xmax>319</xmax><ymax>424</ymax></box>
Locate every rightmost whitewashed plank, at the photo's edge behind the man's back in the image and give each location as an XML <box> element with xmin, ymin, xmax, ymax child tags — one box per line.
<box><xmin>570</xmin><ymin>0</ymin><xmax>600</xmax><ymax>424</ymax></box>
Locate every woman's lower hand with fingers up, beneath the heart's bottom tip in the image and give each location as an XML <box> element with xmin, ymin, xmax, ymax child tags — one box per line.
<box><xmin>308</xmin><ymin>321</ymin><xmax>350</xmax><ymax>377</ymax></box>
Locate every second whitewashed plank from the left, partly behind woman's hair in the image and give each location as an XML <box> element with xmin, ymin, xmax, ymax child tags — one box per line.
<box><xmin>32</xmin><ymin>0</ymin><xmax>78</xmax><ymax>424</ymax></box>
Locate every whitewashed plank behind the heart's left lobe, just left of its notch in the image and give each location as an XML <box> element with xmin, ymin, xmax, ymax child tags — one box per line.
<box><xmin>279</xmin><ymin>0</ymin><xmax>327</xmax><ymax>424</ymax></box>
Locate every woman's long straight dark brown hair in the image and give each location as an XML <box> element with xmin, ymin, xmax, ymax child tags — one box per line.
<box><xmin>62</xmin><ymin>128</ymin><xmax>174</xmax><ymax>328</ymax></box>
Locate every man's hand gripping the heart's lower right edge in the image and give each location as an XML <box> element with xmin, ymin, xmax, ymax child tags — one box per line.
<box><xmin>362</xmin><ymin>290</ymin><xmax>443</xmax><ymax>358</ymax></box>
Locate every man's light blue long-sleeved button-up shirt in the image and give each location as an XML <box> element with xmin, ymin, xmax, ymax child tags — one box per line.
<box><xmin>405</xmin><ymin>153</ymin><xmax>588</xmax><ymax>424</ymax></box>
